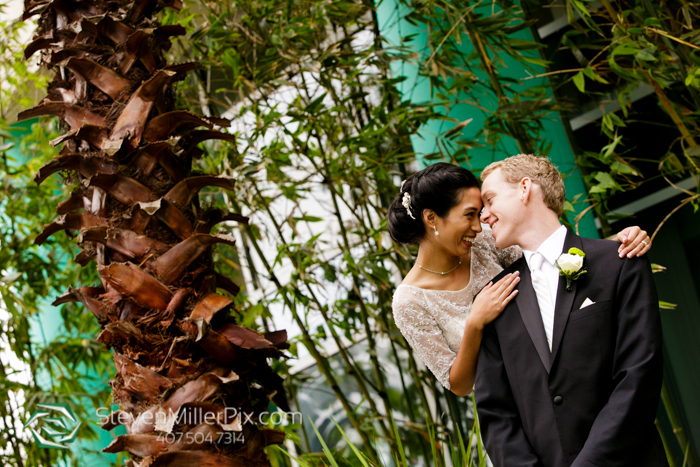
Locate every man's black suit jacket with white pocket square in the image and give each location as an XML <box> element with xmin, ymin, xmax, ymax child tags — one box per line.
<box><xmin>474</xmin><ymin>231</ymin><xmax>668</xmax><ymax>467</ymax></box>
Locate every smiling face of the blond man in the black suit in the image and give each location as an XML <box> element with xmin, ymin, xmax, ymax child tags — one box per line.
<box><xmin>481</xmin><ymin>169</ymin><xmax>524</xmax><ymax>248</ymax></box>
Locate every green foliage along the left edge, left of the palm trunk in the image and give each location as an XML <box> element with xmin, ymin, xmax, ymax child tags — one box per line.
<box><xmin>0</xmin><ymin>9</ymin><xmax>112</xmax><ymax>467</ymax></box>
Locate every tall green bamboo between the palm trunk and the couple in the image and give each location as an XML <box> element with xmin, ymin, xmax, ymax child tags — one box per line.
<box><xmin>164</xmin><ymin>0</ymin><xmax>482</xmax><ymax>465</ymax></box>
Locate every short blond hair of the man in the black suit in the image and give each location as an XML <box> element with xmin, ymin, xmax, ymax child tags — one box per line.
<box><xmin>481</xmin><ymin>154</ymin><xmax>566</xmax><ymax>216</ymax></box>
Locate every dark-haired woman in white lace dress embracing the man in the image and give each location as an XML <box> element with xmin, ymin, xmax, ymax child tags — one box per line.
<box><xmin>389</xmin><ymin>163</ymin><xmax>651</xmax><ymax>396</ymax></box>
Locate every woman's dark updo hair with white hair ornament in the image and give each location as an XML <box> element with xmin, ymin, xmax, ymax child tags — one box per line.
<box><xmin>389</xmin><ymin>162</ymin><xmax>479</xmax><ymax>245</ymax></box>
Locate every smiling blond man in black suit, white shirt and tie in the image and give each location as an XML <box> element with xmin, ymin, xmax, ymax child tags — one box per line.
<box><xmin>474</xmin><ymin>155</ymin><xmax>668</xmax><ymax>467</ymax></box>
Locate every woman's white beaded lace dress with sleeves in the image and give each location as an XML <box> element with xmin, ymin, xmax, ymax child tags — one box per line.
<box><xmin>392</xmin><ymin>226</ymin><xmax>522</xmax><ymax>389</ymax></box>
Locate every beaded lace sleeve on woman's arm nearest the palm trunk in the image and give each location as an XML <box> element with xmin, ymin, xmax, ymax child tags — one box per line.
<box><xmin>392</xmin><ymin>286</ymin><xmax>457</xmax><ymax>389</ymax></box>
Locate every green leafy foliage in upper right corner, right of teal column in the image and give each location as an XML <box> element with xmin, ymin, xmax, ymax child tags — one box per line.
<box><xmin>548</xmin><ymin>0</ymin><xmax>700</xmax><ymax>239</ymax></box>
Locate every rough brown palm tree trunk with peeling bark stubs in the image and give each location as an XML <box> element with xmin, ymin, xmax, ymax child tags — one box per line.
<box><xmin>19</xmin><ymin>0</ymin><xmax>289</xmax><ymax>467</ymax></box>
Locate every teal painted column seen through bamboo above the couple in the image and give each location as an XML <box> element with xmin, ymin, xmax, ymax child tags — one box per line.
<box><xmin>377</xmin><ymin>0</ymin><xmax>599</xmax><ymax>238</ymax></box>
